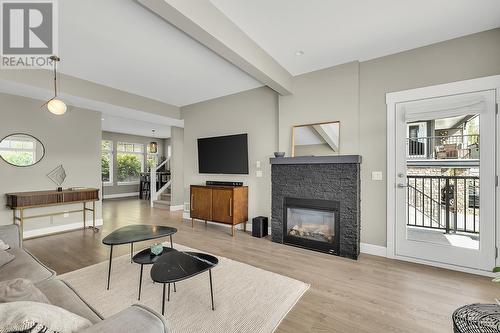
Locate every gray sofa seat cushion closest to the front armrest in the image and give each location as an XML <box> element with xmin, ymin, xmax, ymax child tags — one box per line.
<box><xmin>36</xmin><ymin>279</ymin><xmax>102</xmax><ymax>323</ymax></box>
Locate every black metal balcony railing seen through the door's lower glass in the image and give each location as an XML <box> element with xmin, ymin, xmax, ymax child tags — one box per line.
<box><xmin>407</xmin><ymin>176</ymin><xmax>480</xmax><ymax>233</ymax></box>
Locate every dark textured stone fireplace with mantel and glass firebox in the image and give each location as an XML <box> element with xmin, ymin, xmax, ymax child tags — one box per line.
<box><xmin>271</xmin><ymin>155</ymin><xmax>361</xmax><ymax>259</ymax></box>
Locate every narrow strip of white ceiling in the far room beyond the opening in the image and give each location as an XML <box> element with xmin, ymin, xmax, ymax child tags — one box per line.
<box><xmin>102</xmin><ymin>115</ymin><xmax>171</xmax><ymax>139</ymax></box>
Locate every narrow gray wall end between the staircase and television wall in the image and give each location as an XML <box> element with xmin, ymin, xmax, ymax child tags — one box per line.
<box><xmin>170</xmin><ymin>127</ymin><xmax>184</xmax><ymax>206</ymax></box>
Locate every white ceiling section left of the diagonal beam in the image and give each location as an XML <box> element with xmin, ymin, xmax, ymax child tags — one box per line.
<box><xmin>59</xmin><ymin>0</ymin><xmax>262</xmax><ymax>106</ymax></box>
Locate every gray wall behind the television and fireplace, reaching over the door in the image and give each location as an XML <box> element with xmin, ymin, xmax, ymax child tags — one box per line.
<box><xmin>181</xmin><ymin>29</ymin><xmax>500</xmax><ymax>246</ymax></box>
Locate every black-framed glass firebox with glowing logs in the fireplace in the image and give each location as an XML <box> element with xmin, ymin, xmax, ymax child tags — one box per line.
<box><xmin>283</xmin><ymin>197</ymin><xmax>340</xmax><ymax>255</ymax></box>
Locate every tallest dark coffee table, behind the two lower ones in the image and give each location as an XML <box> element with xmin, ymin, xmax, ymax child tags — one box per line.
<box><xmin>102</xmin><ymin>224</ymin><xmax>177</xmax><ymax>290</ymax></box>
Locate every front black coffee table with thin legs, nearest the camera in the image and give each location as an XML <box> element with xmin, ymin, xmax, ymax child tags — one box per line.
<box><xmin>151</xmin><ymin>251</ymin><xmax>219</xmax><ymax>315</ymax></box>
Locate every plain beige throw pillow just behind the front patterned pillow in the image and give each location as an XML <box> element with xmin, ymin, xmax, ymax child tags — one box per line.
<box><xmin>0</xmin><ymin>279</ymin><xmax>50</xmax><ymax>304</ymax></box>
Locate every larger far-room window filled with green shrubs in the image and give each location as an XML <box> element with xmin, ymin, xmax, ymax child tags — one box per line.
<box><xmin>116</xmin><ymin>142</ymin><xmax>144</xmax><ymax>185</ymax></box>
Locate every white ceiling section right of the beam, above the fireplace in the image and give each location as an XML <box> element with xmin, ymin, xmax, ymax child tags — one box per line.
<box><xmin>210</xmin><ymin>0</ymin><xmax>500</xmax><ymax>75</ymax></box>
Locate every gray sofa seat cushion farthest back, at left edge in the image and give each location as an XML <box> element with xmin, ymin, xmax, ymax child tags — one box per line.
<box><xmin>0</xmin><ymin>248</ymin><xmax>54</xmax><ymax>283</ymax></box>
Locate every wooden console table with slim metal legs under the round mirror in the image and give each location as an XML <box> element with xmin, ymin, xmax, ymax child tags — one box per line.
<box><xmin>5</xmin><ymin>188</ymin><xmax>99</xmax><ymax>240</ymax></box>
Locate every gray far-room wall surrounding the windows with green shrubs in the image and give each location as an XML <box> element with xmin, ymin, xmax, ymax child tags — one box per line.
<box><xmin>102</xmin><ymin>131</ymin><xmax>166</xmax><ymax>195</ymax></box>
